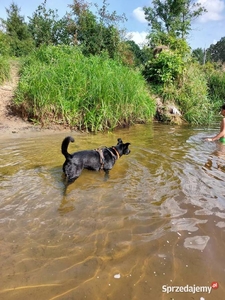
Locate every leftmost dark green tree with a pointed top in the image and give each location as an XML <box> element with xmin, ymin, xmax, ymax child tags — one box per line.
<box><xmin>2</xmin><ymin>3</ymin><xmax>33</xmax><ymax>56</ymax></box>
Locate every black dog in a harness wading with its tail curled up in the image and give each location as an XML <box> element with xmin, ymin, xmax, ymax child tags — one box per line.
<box><xmin>61</xmin><ymin>136</ymin><xmax>130</xmax><ymax>183</ymax></box>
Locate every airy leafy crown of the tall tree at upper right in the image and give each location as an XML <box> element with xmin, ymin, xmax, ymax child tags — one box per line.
<box><xmin>144</xmin><ymin>0</ymin><xmax>206</xmax><ymax>46</ymax></box>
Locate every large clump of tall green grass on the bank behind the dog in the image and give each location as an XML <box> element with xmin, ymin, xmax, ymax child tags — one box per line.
<box><xmin>15</xmin><ymin>46</ymin><xmax>155</xmax><ymax>131</ymax></box>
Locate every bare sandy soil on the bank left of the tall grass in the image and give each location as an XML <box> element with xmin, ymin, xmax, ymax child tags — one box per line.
<box><xmin>0</xmin><ymin>64</ymin><xmax>70</xmax><ymax>137</ymax></box>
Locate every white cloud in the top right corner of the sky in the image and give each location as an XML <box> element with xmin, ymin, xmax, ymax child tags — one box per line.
<box><xmin>197</xmin><ymin>0</ymin><xmax>225</xmax><ymax>23</ymax></box>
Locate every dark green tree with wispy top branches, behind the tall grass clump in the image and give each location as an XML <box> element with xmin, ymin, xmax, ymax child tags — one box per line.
<box><xmin>67</xmin><ymin>0</ymin><xmax>124</xmax><ymax>58</ymax></box>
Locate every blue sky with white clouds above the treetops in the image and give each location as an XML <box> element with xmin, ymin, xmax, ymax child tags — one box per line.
<box><xmin>0</xmin><ymin>0</ymin><xmax>225</xmax><ymax>49</ymax></box>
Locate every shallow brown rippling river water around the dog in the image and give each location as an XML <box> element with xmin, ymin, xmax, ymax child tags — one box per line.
<box><xmin>0</xmin><ymin>124</ymin><xmax>225</xmax><ymax>300</ymax></box>
